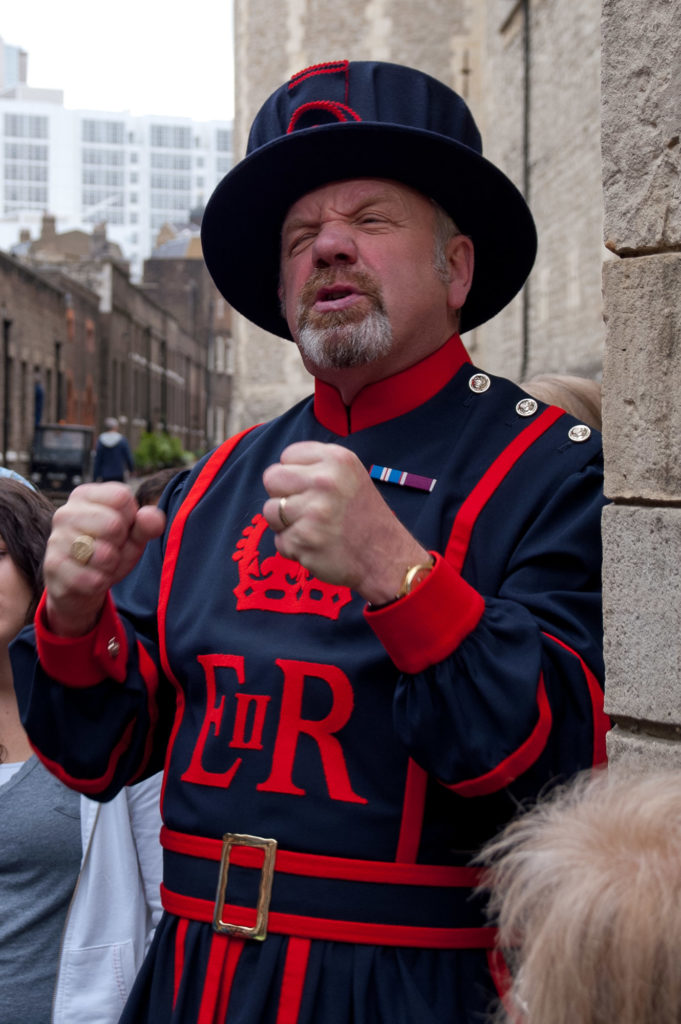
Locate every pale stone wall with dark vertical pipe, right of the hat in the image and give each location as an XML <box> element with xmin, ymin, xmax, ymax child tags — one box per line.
<box><xmin>475</xmin><ymin>0</ymin><xmax>604</xmax><ymax>379</ymax></box>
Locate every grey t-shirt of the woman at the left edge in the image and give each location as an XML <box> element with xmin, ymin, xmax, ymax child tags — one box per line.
<box><xmin>0</xmin><ymin>755</ymin><xmax>82</xmax><ymax>1024</ymax></box>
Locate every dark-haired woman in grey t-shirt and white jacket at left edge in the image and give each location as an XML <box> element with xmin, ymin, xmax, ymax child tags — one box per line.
<box><xmin>0</xmin><ymin>478</ymin><xmax>161</xmax><ymax>1024</ymax></box>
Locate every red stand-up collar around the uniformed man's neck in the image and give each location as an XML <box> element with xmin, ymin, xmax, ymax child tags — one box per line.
<box><xmin>314</xmin><ymin>334</ymin><xmax>470</xmax><ymax>437</ymax></box>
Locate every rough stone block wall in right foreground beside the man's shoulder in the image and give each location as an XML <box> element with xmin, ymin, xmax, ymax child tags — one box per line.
<box><xmin>602</xmin><ymin>0</ymin><xmax>681</xmax><ymax>767</ymax></box>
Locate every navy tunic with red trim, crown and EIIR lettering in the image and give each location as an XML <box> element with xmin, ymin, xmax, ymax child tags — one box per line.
<box><xmin>14</xmin><ymin>337</ymin><xmax>607</xmax><ymax>1024</ymax></box>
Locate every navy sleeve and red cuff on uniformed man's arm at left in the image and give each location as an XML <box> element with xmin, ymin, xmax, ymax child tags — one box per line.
<box><xmin>10</xmin><ymin>474</ymin><xmax>186</xmax><ymax>800</ymax></box>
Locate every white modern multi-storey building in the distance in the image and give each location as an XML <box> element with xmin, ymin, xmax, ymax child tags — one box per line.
<box><xmin>0</xmin><ymin>39</ymin><xmax>232</xmax><ymax>280</ymax></box>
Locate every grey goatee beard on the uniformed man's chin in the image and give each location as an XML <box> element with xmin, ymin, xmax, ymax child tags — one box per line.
<box><xmin>298</xmin><ymin>308</ymin><xmax>392</xmax><ymax>370</ymax></box>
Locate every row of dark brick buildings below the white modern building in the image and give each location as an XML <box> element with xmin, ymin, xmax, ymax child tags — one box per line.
<box><xmin>0</xmin><ymin>216</ymin><xmax>231</xmax><ymax>472</ymax></box>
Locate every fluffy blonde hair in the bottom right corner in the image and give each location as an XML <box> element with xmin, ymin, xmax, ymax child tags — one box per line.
<box><xmin>482</xmin><ymin>768</ymin><xmax>681</xmax><ymax>1024</ymax></box>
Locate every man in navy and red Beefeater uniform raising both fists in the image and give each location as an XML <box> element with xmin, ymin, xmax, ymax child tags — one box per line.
<box><xmin>13</xmin><ymin>60</ymin><xmax>607</xmax><ymax>1024</ymax></box>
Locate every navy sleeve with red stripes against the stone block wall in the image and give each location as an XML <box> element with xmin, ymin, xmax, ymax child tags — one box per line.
<box><xmin>394</xmin><ymin>465</ymin><xmax>608</xmax><ymax>797</ymax></box>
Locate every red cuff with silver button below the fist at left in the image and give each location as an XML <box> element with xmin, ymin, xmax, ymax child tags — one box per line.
<box><xmin>35</xmin><ymin>594</ymin><xmax>128</xmax><ymax>687</ymax></box>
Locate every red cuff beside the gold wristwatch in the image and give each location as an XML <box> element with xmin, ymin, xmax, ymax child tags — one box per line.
<box><xmin>365</xmin><ymin>552</ymin><xmax>484</xmax><ymax>676</ymax></box>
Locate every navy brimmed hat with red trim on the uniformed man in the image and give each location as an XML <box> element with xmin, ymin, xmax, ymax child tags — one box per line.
<box><xmin>202</xmin><ymin>60</ymin><xmax>537</xmax><ymax>338</ymax></box>
